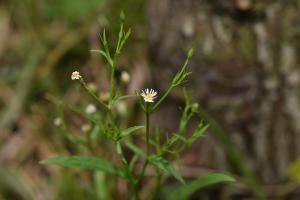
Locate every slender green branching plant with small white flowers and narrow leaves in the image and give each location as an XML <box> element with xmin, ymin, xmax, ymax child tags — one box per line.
<box><xmin>41</xmin><ymin>16</ymin><xmax>234</xmax><ymax>199</ymax></box>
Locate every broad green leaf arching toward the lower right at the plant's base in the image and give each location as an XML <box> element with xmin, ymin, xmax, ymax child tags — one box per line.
<box><xmin>167</xmin><ymin>173</ymin><xmax>235</xmax><ymax>200</ymax></box>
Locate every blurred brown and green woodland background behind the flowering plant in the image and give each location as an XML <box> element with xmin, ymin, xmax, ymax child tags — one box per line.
<box><xmin>0</xmin><ymin>0</ymin><xmax>300</xmax><ymax>200</ymax></box>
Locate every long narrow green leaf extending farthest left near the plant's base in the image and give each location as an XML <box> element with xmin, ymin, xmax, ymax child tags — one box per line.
<box><xmin>40</xmin><ymin>156</ymin><xmax>124</xmax><ymax>177</ymax></box>
